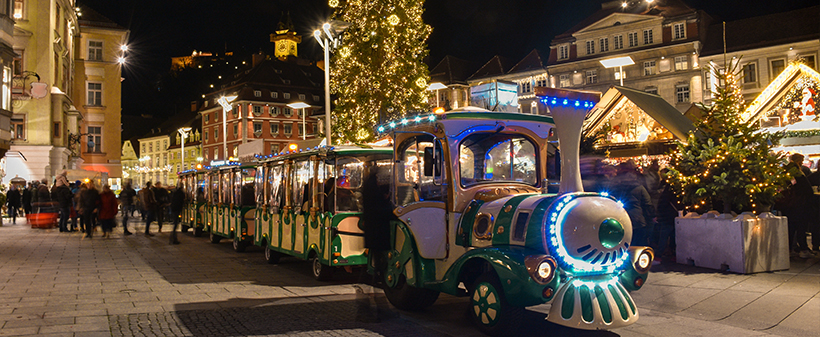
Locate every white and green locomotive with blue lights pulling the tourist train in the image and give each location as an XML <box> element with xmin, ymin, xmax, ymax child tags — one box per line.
<box><xmin>368</xmin><ymin>88</ymin><xmax>654</xmax><ymax>335</ymax></box>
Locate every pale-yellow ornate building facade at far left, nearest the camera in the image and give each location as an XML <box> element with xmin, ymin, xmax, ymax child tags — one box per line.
<box><xmin>6</xmin><ymin>0</ymin><xmax>81</xmax><ymax>182</ymax></box>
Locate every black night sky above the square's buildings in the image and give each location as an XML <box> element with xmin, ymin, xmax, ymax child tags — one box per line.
<box><xmin>78</xmin><ymin>0</ymin><xmax>818</xmax><ymax>115</ymax></box>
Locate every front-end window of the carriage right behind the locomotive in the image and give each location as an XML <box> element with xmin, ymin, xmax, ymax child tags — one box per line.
<box><xmin>335</xmin><ymin>157</ymin><xmax>364</xmax><ymax>212</ymax></box>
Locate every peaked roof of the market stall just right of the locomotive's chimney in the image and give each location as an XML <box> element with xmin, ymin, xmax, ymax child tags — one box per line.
<box><xmin>584</xmin><ymin>86</ymin><xmax>695</xmax><ymax>140</ymax></box>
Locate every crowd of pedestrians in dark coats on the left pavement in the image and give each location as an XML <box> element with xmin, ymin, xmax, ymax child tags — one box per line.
<box><xmin>6</xmin><ymin>171</ymin><xmax>186</xmax><ymax>244</ymax></box>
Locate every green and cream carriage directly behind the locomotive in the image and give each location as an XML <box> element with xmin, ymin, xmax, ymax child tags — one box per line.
<box><xmin>253</xmin><ymin>146</ymin><xmax>392</xmax><ymax>280</ymax></box>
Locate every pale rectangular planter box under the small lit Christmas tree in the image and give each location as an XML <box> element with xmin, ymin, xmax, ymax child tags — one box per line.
<box><xmin>675</xmin><ymin>213</ymin><xmax>789</xmax><ymax>274</ymax></box>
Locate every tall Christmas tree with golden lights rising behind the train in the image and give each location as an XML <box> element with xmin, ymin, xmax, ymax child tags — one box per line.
<box><xmin>330</xmin><ymin>0</ymin><xmax>431</xmax><ymax>143</ymax></box>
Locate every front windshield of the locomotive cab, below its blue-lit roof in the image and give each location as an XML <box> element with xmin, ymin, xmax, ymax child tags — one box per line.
<box><xmin>459</xmin><ymin>133</ymin><xmax>538</xmax><ymax>187</ymax></box>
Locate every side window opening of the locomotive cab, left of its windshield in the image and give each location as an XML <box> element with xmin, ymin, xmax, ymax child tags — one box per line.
<box><xmin>394</xmin><ymin>135</ymin><xmax>444</xmax><ymax>205</ymax></box>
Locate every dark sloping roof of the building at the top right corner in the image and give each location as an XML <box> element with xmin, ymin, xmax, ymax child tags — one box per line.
<box><xmin>701</xmin><ymin>6</ymin><xmax>820</xmax><ymax>56</ymax></box>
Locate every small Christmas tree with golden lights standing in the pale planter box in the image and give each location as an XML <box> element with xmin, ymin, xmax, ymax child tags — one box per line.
<box><xmin>666</xmin><ymin>60</ymin><xmax>789</xmax><ymax>213</ymax></box>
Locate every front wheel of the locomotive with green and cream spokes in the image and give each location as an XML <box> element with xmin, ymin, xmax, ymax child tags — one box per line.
<box><xmin>470</xmin><ymin>273</ymin><xmax>525</xmax><ymax>336</ymax></box>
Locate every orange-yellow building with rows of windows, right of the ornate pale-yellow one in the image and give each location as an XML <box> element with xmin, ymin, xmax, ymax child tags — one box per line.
<box><xmin>70</xmin><ymin>8</ymin><xmax>129</xmax><ymax>189</ymax></box>
